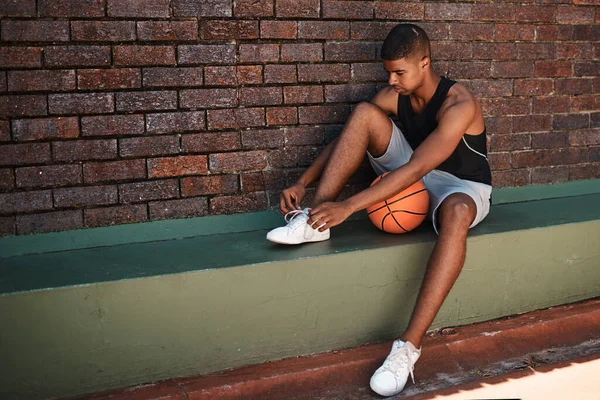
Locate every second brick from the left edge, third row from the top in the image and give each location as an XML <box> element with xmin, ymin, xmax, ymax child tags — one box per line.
<box><xmin>44</xmin><ymin>45</ymin><xmax>111</xmax><ymax>68</ymax></box>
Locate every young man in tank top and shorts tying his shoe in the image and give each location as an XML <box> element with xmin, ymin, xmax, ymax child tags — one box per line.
<box><xmin>267</xmin><ymin>24</ymin><xmax>492</xmax><ymax>396</ymax></box>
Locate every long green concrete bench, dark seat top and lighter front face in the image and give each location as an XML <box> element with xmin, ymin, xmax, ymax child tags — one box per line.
<box><xmin>0</xmin><ymin>183</ymin><xmax>600</xmax><ymax>399</ymax></box>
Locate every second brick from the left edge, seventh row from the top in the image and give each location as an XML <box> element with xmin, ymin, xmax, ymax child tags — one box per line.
<box><xmin>52</xmin><ymin>139</ymin><xmax>117</xmax><ymax>162</ymax></box>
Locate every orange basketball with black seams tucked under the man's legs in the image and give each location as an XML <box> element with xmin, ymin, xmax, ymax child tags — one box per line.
<box><xmin>367</xmin><ymin>172</ymin><xmax>429</xmax><ymax>233</ymax></box>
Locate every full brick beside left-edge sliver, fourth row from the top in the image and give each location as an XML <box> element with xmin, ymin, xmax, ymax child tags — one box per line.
<box><xmin>8</xmin><ymin>70</ymin><xmax>75</xmax><ymax>92</ymax></box>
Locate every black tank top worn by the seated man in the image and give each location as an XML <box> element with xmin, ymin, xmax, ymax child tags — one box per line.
<box><xmin>397</xmin><ymin>77</ymin><xmax>492</xmax><ymax>185</ymax></box>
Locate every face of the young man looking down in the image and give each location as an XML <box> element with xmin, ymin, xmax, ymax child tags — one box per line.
<box><xmin>383</xmin><ymin>56</ymin><xmax>429</xmax><ymax>96</ymax></box>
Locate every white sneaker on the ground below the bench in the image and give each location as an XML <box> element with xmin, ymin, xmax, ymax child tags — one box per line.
<box><xmin>371</xmin><ymin>339</ymin><xmax>421</xmax><ymax>396</ymax></box>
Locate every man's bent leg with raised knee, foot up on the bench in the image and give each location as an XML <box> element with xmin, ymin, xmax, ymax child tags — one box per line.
<box><xmin>311</xmin><ymin>102</ymin><xmax>392</xmax><ymax>208</ymax></box>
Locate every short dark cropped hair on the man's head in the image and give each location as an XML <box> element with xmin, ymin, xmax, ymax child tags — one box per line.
<box><xmin>381</xmin><ymin>24</ymin><xmax>431</xmax><ymax>61</ymax></box>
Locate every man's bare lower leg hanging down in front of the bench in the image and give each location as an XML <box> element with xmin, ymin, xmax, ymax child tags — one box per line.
<box><xmin>401</xmin><ymin>193</ymin><xmax>477</xmax><ymax>348</ymax></box>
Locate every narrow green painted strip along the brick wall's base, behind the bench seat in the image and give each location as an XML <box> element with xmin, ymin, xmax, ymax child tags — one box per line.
<box><xmin>0</xmin><ymin>179</ymin><xmax>600</xmax><ymax>259</ymax></box>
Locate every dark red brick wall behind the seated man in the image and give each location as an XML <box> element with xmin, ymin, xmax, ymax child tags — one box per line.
<box><xmin>0</xmin><ymin>0</ymin><xmax>600</xmax><ymax>235</ymax></box>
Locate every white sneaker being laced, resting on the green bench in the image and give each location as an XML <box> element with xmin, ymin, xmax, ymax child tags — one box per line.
<box><xmin>267</xmin><ymin>208</ymin><xmax>329</xmax><ymax>244</ymax></box>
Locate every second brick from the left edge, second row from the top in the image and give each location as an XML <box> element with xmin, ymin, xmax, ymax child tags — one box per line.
<box><xmin>71</xmin><ymin>21</ymin><xmax>136</xmax><ymax>42</ymax></box>
